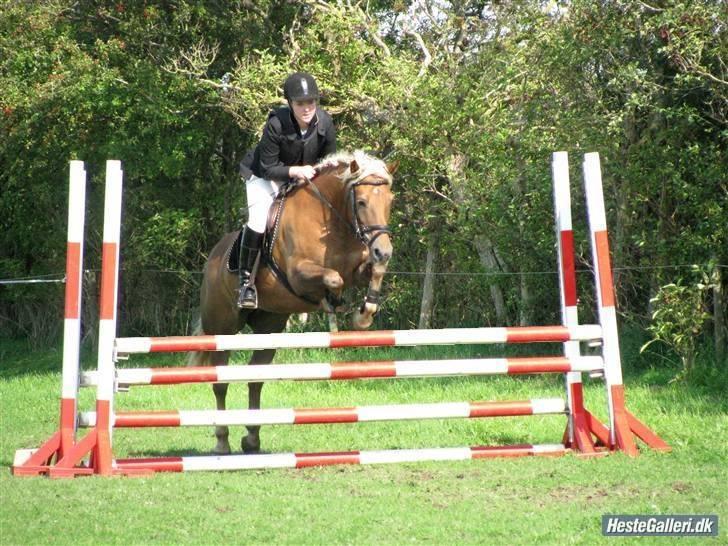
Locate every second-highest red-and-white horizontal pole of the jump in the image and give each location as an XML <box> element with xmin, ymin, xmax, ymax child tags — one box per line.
<box><xmin>81</xmin><ymin>356</ymin><xmax>604</xmax><ymax>387</ymax></box>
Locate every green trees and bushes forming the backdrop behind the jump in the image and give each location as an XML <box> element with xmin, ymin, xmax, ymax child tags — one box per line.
<box><xmin>0</xmin><ymin>0</ymin><xmax>728</xmax><ymax>368</ymax></box>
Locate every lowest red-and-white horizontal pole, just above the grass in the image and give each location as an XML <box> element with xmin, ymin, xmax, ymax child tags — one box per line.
<box><xmin>115</xmin><ymin>444</ymin><xmax>568</xmax><ymax>472</ymax></box>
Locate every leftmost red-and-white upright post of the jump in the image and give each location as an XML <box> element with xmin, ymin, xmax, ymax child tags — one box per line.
<box><xmin>58</xmin><ymin>161</ymin><xmax>86</xmax><ymax>459</ymax></box>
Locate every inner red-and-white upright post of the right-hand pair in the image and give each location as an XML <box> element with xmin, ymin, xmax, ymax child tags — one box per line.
<box><xmin>551</xmin><ymin>152</ymin><xmax>597</xmax><ymax>455</ymax></box>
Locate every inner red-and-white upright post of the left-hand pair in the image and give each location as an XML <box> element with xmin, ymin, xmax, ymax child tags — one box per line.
<box><xmin>93</xmin><ymin>160</ymin><xmax>123</xmax><ymax>475</ymax></box>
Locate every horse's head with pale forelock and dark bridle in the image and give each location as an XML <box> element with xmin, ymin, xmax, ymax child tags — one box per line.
<box><xmin>346</xmin><ymin>156</ymin><xmax>398</xmax><ymax>272</ymax></box>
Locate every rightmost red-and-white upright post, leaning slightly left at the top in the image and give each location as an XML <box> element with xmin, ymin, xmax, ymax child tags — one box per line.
<box><xmin>584</xmin><ymin>152</ymin><xmax>637</xmax><ymax>456</ymax></box>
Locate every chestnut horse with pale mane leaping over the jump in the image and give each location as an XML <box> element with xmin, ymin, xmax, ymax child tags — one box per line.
<box><xmin>189</xmin><ymin>151</ymin><xmax>398</xmax><ymax>454</ymax></box>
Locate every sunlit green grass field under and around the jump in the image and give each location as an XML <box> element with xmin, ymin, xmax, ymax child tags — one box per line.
<box><xmin>0</xmin><ymin>340</ymin><xmax>728</xmax><ymax>545</ymax></box>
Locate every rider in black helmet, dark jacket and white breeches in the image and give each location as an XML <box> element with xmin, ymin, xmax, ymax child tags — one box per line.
<box><xmin>238</xmin><ymin>72</ymin><xmax>336</xmax><ymax>309</ymax></box>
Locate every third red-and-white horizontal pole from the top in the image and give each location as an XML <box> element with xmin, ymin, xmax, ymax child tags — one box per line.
<box><xmin>78</xmin><ymin>398</ymin><xmax>566</xmax><ymax>428</ymax></box>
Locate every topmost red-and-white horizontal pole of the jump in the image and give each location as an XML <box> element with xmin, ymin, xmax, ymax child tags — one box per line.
<box><xmin>116</xmin><ymin>324</ymin><xmax>602</xmax><ymax>355</ymax></box>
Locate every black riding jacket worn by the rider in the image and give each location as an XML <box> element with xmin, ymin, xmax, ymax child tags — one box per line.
<box><xmin>241</xmin><ymin>106</ymin><xmax>336</xmax><ymax>182</ymax></box>
